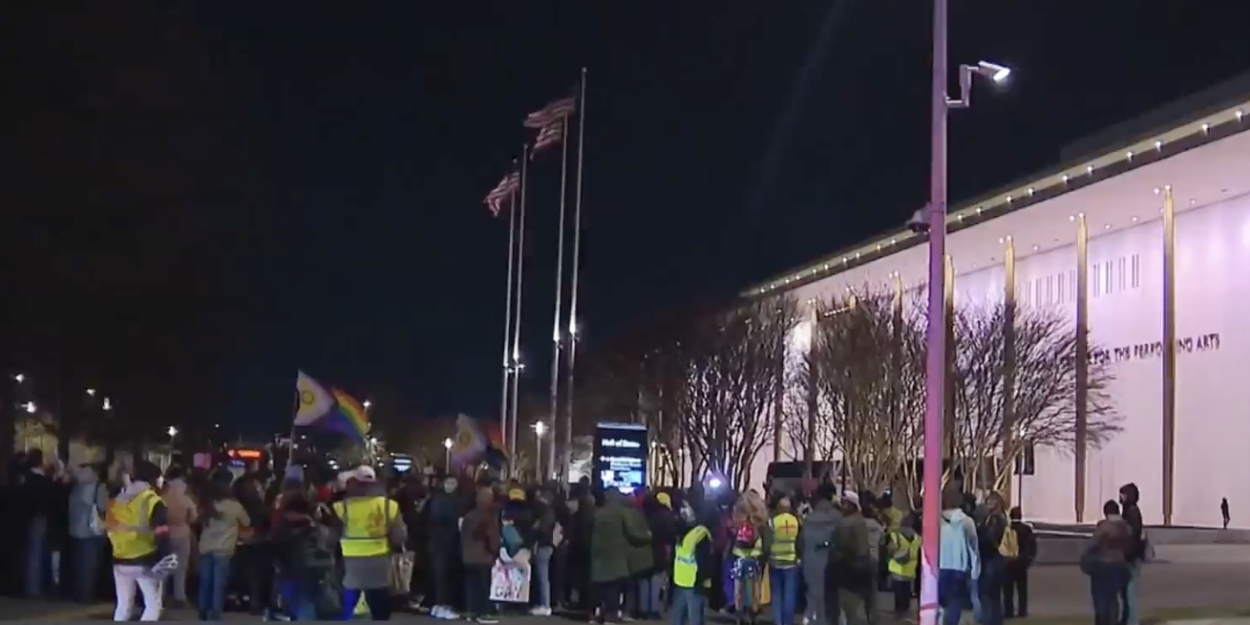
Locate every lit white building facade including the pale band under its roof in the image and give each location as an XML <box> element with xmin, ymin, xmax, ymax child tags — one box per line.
<box><xmin>745</xmin><ymin>93</ymin><xmax>1250</xmax><ymax>528</ymax></box>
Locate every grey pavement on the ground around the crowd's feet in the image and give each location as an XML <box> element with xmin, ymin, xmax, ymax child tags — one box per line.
<box><xmin>7</xmin><ymin>560</ymin><xmax>1250</xmax><ymax>625</ymax></box>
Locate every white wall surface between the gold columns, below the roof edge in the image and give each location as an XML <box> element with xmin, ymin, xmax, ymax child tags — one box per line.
<box><xmin>753</xmin><ymin>133</ymin><xmax>1250</xmax><ymax>526</ymax></box>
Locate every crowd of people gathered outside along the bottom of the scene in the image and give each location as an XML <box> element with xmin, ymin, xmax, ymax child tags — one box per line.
<box><xmin>0</xmin><ymin>451</ymin><xmax>1146</xmax><ymax>625</ymax></box>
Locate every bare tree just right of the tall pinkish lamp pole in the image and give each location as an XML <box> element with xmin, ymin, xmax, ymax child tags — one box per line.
<box><xmin>954</xmin><ymin>304</ymin><xmax>1123</xmax><ymax>489</ymax></box>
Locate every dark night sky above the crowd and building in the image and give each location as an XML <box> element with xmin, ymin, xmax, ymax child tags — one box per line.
<box><xmin>7</xmin><ymin>0</ymin><xmax>1250</xmax><ymax>437</ymax></box>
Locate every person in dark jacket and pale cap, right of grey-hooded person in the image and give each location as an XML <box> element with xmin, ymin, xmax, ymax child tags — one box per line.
<box><xmin>825</xmin><ymin>490</ymin><xmax>876</xmax><ymax>625</ymax></box>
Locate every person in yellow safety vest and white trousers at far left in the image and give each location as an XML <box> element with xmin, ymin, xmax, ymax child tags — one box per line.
<box><xmin>105</xmin><ymin>460</ymin><xmax>170</xmax><ymax>621</ymax></box>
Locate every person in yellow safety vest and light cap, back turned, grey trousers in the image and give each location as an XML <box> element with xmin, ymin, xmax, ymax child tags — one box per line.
<box><xmin>333</xmin><ymin>466</ymin><xmax>408</xmax><ymax>620</ymax></box>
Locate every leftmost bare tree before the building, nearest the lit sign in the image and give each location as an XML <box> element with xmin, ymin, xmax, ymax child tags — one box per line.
<box><xmin>674</xmin><ymin>298</ymin><xmax>798</xmax><ymax>489</ymax></box>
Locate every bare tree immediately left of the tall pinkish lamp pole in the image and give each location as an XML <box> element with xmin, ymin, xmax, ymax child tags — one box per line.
<box><xmin>806</xmin><ymin>293</ymin><xmax>924</xmax><ymax>490</ymax></box>
